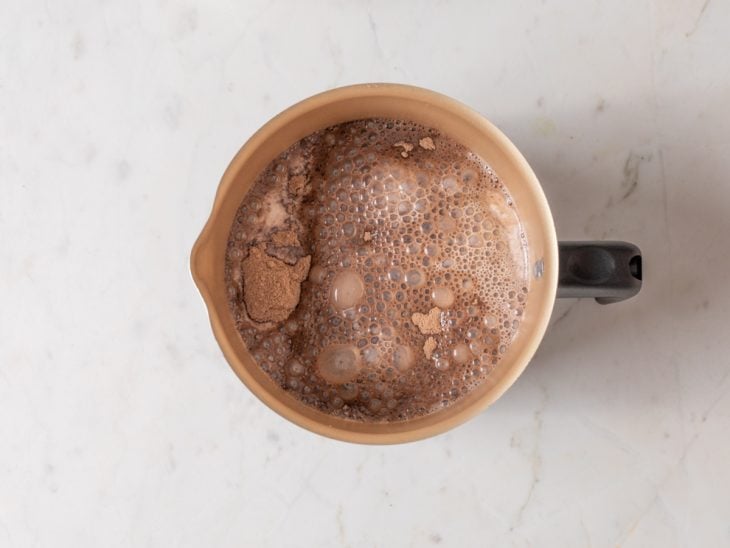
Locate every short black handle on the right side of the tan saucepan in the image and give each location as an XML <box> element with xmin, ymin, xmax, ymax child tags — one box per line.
<box><xmin>558</xmin><ymin>242</ymin><xmax>641</xmax><ymax>304</ymax></box>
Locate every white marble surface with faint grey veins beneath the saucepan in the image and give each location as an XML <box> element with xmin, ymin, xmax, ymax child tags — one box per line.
<box><xmin>0</xmin><ymin>0</ymin><xmax>730</xmax><ymax>547</ymax></box>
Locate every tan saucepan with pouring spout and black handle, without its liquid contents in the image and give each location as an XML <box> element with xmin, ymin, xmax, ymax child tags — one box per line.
<box><xmin>191</xmin><ymin>84</ymin><xmax>641</xmax><ymax>443</ymax></box>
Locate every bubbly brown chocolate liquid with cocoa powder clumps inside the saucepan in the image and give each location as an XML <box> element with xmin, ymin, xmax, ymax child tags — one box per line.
<box><xmin>226</xmin><ymin>119</ymin><xmax>528</xmax><ymax>421</ymax></box>
